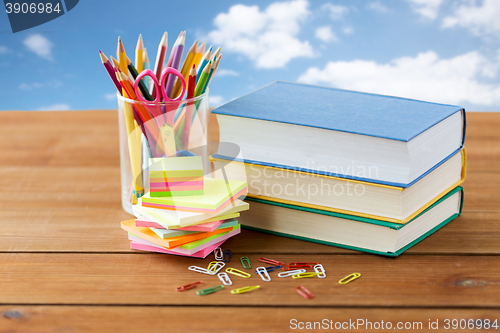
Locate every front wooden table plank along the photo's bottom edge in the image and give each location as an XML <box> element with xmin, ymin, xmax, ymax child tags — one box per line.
<box><xmin>0</xmin><ymin>306</ymin><xmax>500</xmax><ymax>333</ymax></box>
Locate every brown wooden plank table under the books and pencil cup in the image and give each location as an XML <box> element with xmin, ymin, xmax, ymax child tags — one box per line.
<box><xmin>0</xmin><ymin>111</ymin><xmax>500</xmax><ymax>332</ymax></box>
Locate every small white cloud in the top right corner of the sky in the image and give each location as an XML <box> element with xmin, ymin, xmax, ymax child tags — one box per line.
<box><xmin>443</xmin><ymin>0</ymin><xmax>500</xmax><ymax>35</ymax></box>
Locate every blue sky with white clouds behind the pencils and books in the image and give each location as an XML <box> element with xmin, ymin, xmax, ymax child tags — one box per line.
<box><xmin>0</xmin><ymin>0</ymin><xmax>500</xmax><ymax>111</ymax></box>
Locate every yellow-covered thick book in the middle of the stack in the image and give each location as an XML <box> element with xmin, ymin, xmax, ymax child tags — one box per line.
<box><xmin>212</xmin><ymin>148</ymin><xmax>467</xmax><ymax>224</ymax></box>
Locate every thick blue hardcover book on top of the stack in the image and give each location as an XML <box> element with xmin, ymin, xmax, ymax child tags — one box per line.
<box><xmin>212</xmin><ymin>81</ymin><xmax>466</xmax><ymax>187</ymax></box>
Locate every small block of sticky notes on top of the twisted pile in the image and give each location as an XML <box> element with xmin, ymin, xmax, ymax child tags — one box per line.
<box><xmin>149</xmin><ymin>156</ymin><xmax>203</xmax><ymax>197</ymax></box>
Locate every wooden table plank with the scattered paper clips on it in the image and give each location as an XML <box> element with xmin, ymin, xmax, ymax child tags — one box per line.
<box><xmin>0</xmin><ymin>253</ymin><xmax>500</xmax><ymax>307</ymax></box>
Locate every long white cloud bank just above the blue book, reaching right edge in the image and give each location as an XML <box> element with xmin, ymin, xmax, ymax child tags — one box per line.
<box><xmin>298</xmin><ymin>51</ymin><xmax>500</xmax><ymax>106</ymax></box>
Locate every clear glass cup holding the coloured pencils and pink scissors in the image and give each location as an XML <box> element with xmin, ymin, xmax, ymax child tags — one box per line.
<box><xmin>117</xmin><ymin>90</ymin><xmax>212</xmax><ymax>214</ymax></box>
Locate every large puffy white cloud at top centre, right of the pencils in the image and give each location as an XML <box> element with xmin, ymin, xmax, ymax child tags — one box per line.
<box><xmin>208</xmin><ymin>0</ymin><xmax>314</xmax><ymax>68</ymax></box>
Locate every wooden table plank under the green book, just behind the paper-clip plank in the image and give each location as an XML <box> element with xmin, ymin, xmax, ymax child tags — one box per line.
<box><xmin>0</xmin><ymin>208</ymin><xmax>500</xmax><ymax>256</ymax></box>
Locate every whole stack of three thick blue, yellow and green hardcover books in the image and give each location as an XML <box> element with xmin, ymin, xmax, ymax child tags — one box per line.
<box><xmin>212</xmin><ymin>81</ymin><xmax>466</xmax><ymax>256</ymax></box>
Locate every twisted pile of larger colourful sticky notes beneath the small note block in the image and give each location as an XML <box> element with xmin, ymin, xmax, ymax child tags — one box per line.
<box><xmin>121</xmin><ymin>175</ymin><xmax>249</xmax><ymax>258</ymax></box>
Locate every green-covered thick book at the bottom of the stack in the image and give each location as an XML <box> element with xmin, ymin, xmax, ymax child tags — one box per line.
<box><xmin>238</xmin><ymin>186</ymin><xmax>463</xmax><ymax>257</ymax></box>
